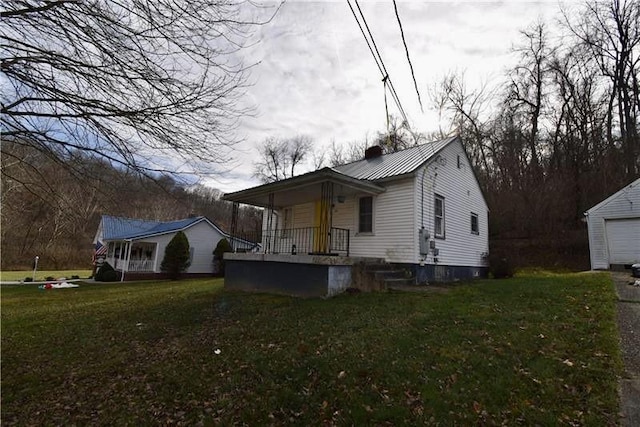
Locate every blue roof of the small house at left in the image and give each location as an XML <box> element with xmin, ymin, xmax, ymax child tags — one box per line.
<box><xmin>101</xmin><ymin>215</ymin><xmax>222</xmax><ymax>240</ymax></box>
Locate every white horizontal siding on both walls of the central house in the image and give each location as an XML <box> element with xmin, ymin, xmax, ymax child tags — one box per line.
<box><xmin>251</xmin><ymin>140</ymin><xmax>489</xmax><ymax>267</ymax></box>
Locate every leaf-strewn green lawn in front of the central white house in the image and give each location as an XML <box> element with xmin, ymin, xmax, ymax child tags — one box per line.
<box><xmin>1</xmin><ymin>274</ymin><xmax>621</xmax><ymax>425</ymax></box>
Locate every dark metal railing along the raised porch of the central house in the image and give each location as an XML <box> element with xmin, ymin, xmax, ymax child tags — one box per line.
<box><xmin>235</xmin><ymin>227</ymin><xmax>349</xmax><ymax>256</ymax></box>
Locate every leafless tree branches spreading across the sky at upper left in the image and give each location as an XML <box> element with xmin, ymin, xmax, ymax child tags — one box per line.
<box><xmin>0</xmin><ymin>0</ymin><xmax>278</xmax><ymax>180</ymax></box>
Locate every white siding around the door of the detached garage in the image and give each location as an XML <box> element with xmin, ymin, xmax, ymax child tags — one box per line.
<box><xmin>587</xmin><ymin>179</ymin><xmax>640</xmax><ymax>270</ymax></box>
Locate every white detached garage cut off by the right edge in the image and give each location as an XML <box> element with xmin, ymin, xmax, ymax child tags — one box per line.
<box><xmin>584</xmin><ymin>178</ymin><xmax>640</xmax><ymax>270</ymax></box>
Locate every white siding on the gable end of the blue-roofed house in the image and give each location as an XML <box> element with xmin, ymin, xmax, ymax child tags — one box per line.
<box><xmin>137</xmin><ymin>221</ymin><xmax>223</xmax><ymax>273</ymax></box>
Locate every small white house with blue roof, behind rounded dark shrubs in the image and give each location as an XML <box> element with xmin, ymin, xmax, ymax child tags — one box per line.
<box><xmin>94</xmin><ymin>215</ymin><xmax>257</xmax><ymax>278</ymax></box>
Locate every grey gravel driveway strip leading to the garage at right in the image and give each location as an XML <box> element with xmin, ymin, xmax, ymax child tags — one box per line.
<box><xmin>611</xmin><ymin>272</ymin><xmax>640</xmax><ymax>427</ymax></box>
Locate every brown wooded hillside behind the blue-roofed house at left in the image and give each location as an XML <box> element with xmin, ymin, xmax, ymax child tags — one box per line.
<box><xmin>1</xmin><ymin>144</ymin><xmax>262</xmax><ymax>270</ymax></box>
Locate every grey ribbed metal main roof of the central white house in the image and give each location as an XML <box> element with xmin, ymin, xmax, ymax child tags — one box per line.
<box><xmin>333</xmin><ymin>136</ymin><xmax>457</xmax><ymax>181</ymax></box>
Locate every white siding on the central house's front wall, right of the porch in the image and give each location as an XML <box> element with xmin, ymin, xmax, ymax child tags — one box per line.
<box><xmin>333</xmin><ymin>178</ymin><xmax>416</xmax><ymax>262</ymax></box>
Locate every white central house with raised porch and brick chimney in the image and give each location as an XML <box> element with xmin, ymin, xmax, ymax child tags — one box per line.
<box><xmin>224</xmin><ymin>137</ymin><xmax>489</xmax><ymax>295</ymax></box>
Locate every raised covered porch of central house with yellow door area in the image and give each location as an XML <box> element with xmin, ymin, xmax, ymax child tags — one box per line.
<box><xmin>224</xmin><ymin>168</ymin><xmax>385</xmax><ymax>296</ymax></box>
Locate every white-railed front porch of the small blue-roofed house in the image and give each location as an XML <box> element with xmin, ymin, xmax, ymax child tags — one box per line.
<box><xmin>105</xmin><ymin>241</ymin><xmax>158</xmax><ymax>273</ymax></box>
